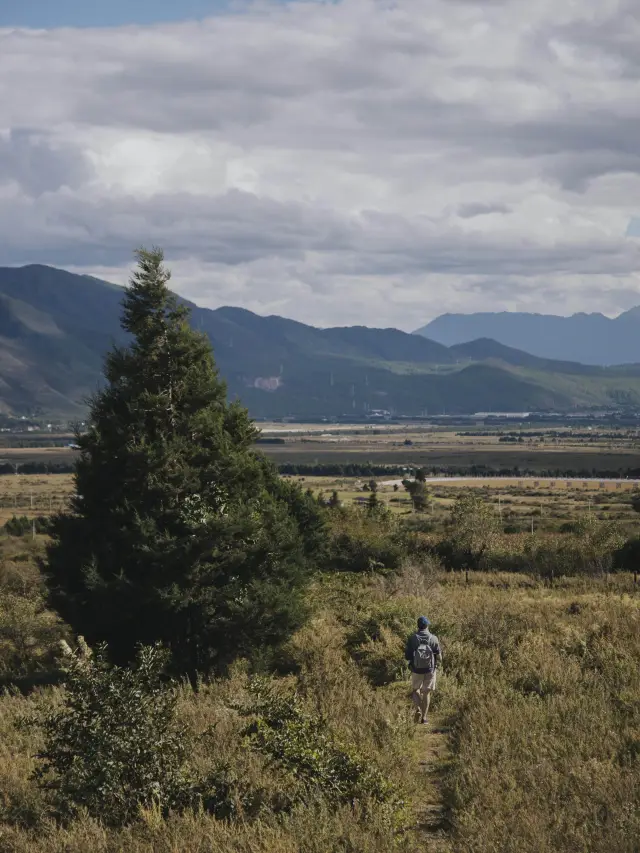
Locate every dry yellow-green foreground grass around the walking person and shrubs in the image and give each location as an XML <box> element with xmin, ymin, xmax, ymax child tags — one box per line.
<box><xmin>0</xmin><ymin>543</ymin><xmax>640</xmax><ymax>853</ymax></box>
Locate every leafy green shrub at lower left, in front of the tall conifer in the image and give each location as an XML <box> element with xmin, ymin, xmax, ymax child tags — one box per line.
<box><xmin>31</xmin><ymin>640</ymin><xmax>195</xmax><ymax>825</ymax></box>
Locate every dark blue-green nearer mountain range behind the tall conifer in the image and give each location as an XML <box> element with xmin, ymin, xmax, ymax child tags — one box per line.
<box><xmin>0</xmin><ymin>266</ymin><xmax>640</xmax><ymax>418</ymax></box>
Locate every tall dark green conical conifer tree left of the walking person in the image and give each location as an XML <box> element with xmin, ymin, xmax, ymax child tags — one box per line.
<box><xmin>46</xmin><ymin>250</ymin><xmax>323</xmax><ymax>680</ymax></box>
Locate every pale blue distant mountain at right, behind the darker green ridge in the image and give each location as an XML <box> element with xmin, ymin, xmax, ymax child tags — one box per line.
<box><xmin>416</xmin><ymin>307</ymin><xmax>640</xmax><ymax>365</ymax></box>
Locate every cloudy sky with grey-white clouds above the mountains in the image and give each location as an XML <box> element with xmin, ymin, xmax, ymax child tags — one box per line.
<box><xmin>0</xmin><ymin>0</ymin><xmax>640</xmax><ymax>331</ymax></box>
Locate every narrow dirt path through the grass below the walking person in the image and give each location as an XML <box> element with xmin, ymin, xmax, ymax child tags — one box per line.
<box><xmin>414</xmin><ymin>714</ymin><xmax>452</xmax><ymax>853</ymax></box>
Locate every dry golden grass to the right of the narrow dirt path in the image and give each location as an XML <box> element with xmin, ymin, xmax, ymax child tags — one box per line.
<box><xmin>422</xmin><ymin>576</ymin><xmax>640</xmax><ymax>853</ymax></box>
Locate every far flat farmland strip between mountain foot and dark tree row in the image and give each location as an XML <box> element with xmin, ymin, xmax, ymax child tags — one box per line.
<box><xmin>6</xmin><ymin>423</ymin><xmax>640</xmax><ymax>477</ymax></box>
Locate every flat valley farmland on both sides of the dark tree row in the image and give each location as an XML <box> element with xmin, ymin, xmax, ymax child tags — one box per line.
<box><xmin>0</xmin><ymin>424</ymin><xmax>640</xmax><ymax>531</ymax></box>
